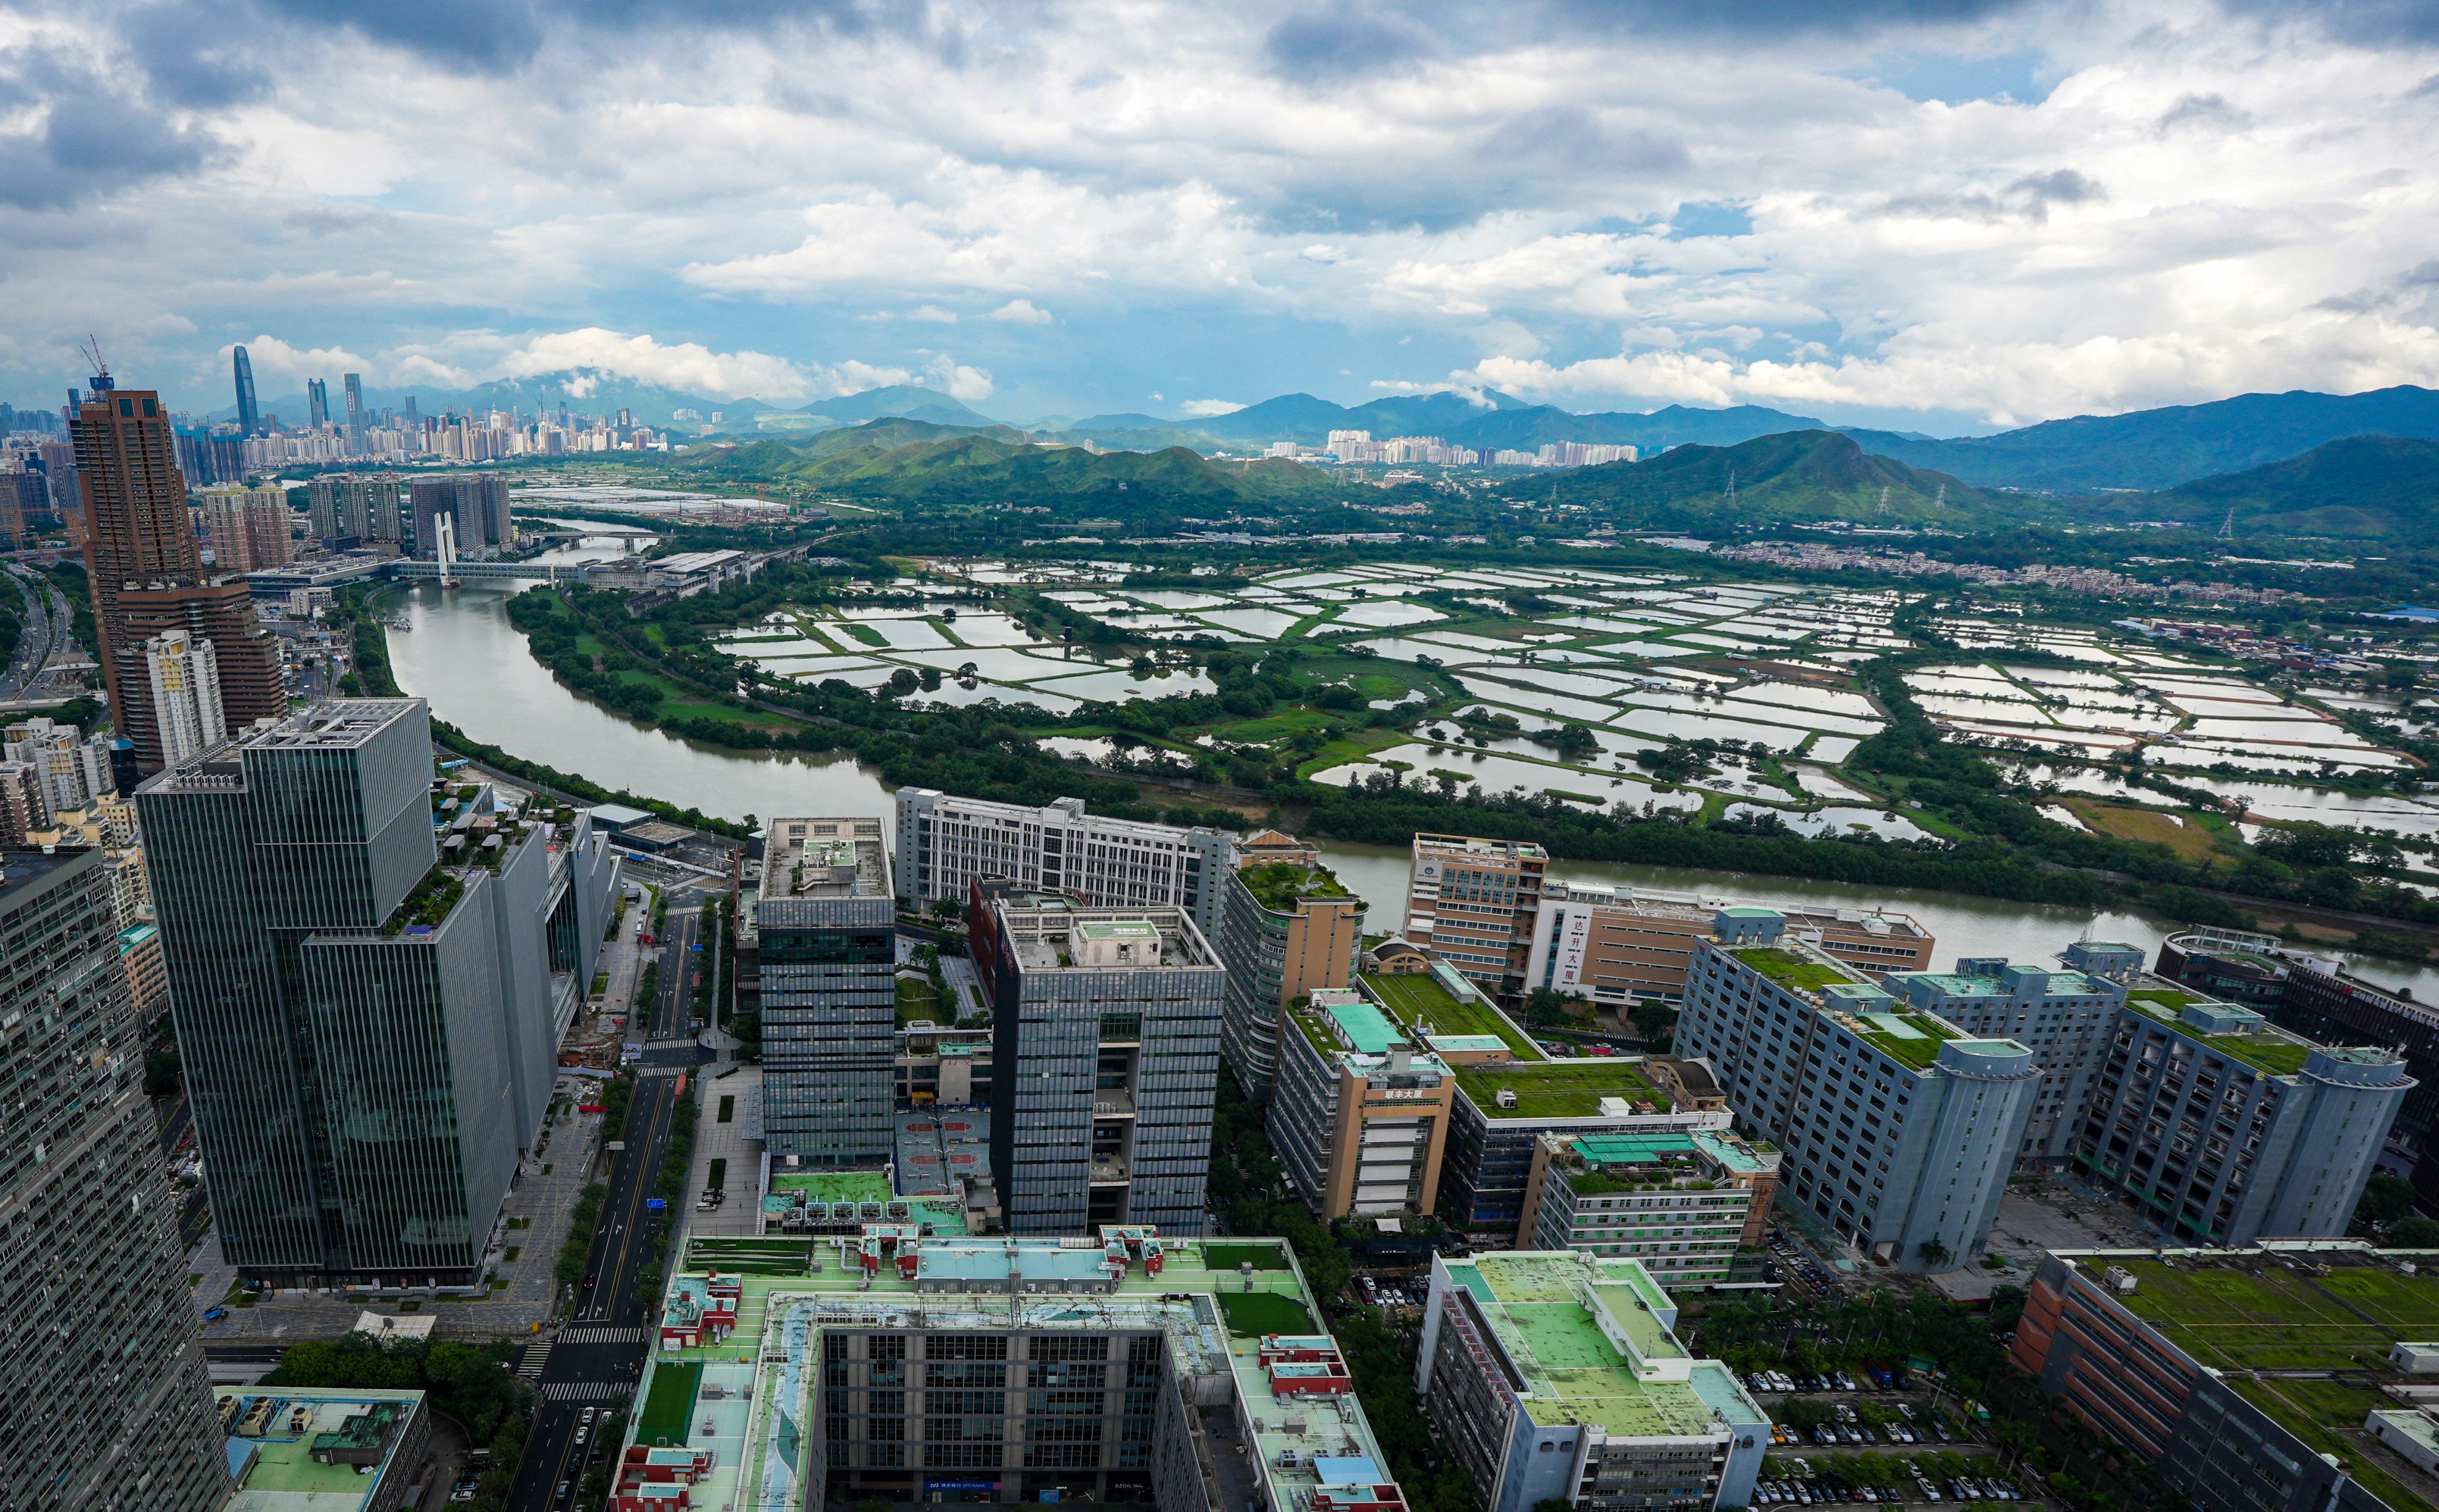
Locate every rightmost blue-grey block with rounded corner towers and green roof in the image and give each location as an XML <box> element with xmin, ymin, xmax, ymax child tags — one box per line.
<box><xmin>2073</xmin><ymin>978</ymin><xmax>2415</xmax><ymax>1246</ymax></box>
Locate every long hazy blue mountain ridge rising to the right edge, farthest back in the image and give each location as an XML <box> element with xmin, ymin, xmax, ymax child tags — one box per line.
<box><xmin>1846</xmin><ymin>385</ymin><xmax>2439</xmax><ymax>492</ymax></box>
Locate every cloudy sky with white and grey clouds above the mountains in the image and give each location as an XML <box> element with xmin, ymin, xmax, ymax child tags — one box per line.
<box><xmin>0</xmin><ymin>0</ymin><xmax>2439</xmax><ymax>434</ymax></box>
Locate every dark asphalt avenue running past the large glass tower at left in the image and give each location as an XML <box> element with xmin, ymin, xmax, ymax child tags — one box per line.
<box><xmin>507</xmin><ymin>895</ymin><xmax>697</xmax><ymax>1512</ymax></box>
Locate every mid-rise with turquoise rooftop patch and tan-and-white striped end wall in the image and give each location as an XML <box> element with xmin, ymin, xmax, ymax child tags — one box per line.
<box><xmin>1268</xmin><ymin>988</ymin><xmax>1456</xmax><ymax>1222</ymax></box>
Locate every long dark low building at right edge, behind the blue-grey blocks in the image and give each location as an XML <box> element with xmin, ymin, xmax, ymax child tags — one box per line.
<box><xmin>2158</xmin><ymin>929</ymin><xmax>2439</xmax><ymax>1207</ymax></box>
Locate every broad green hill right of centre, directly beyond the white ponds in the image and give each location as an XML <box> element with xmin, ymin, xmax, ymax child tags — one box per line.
<box><xmin>1510</xmin><ymin>432</ymin><xmax>1998</xmax><ymax>529</ymax></box>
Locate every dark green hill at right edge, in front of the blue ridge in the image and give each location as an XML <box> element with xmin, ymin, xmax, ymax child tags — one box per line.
<box><xmin>2136</xmin><ymin>437</ymin><xmax>2439</xmax><ymax>537</ymax></box>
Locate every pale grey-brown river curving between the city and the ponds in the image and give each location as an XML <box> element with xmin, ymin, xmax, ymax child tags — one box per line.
<box><xmin>381</xmin><ymin>537</ymin><xmax>2439</xmax><ymax>1002</ymax></box>
